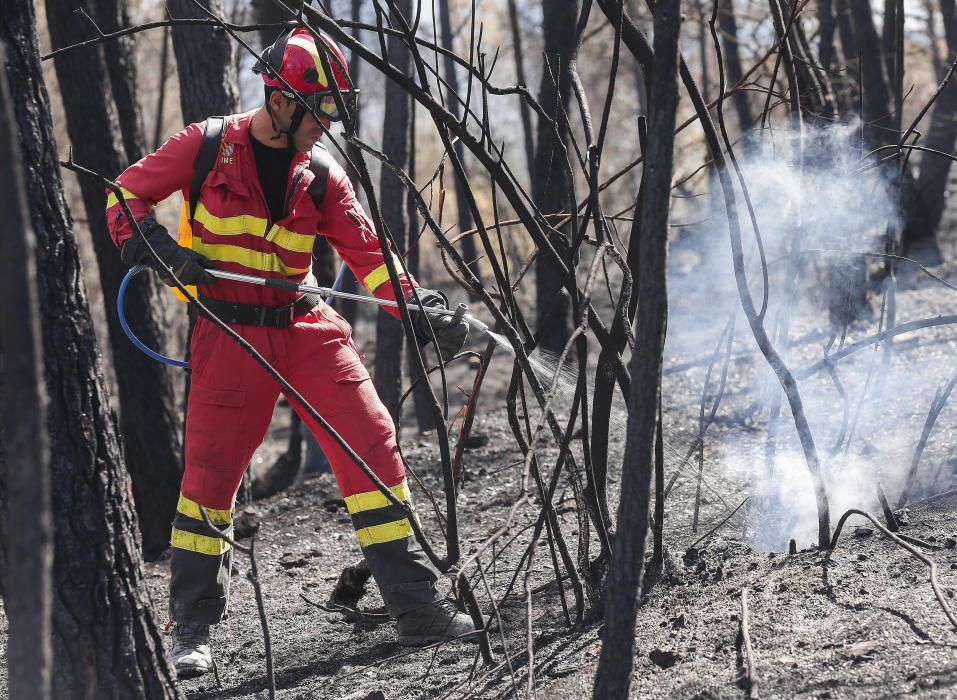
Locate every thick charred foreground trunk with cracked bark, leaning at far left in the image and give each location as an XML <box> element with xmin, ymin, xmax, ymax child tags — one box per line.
<box><xmin>0</xmin><ymin>0</ymin><xmax>181</xmax><ymax>698</ymax></box>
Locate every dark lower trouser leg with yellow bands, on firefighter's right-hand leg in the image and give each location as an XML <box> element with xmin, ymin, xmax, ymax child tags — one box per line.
<box><xmin>345</xmin><ymin>481</ymin><xmax>441</xmax><ymax>617</ymax></box>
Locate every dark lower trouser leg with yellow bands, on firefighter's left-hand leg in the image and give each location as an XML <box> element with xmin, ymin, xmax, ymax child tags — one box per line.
<box><xmin>169</xmin><ymin>496</ymin><xmax>233</xmax><ymax>625</ymax></box>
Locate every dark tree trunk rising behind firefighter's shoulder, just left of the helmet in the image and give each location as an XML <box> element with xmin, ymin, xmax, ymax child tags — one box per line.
<box><xmin>167</xmin><ymin>0</ymin><xmax>239</xmax><ymax>124</ymax></box>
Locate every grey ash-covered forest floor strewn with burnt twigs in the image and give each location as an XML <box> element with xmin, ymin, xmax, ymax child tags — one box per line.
<box><xmin>138</xmin><ymin>253</ymin><xmax>957</xmax><ymax>698</ymax></box>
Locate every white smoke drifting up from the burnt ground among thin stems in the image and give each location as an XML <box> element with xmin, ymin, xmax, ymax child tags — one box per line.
<box><xmin>668</xmin><ymin>124</ymin><xmax>953</xmax><ymax>550</ymax></box>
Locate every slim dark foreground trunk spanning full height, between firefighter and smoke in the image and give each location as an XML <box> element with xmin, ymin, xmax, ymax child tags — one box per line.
<box><xmin>593</xmin><ymin>0</ymin><xmax>681</xmax><ymax>700</ymax></box>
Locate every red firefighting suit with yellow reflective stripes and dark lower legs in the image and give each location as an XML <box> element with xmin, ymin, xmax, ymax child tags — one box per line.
<box><xmin>107</xmin><ymin>113</ymin><xmax>439</xmax><ymax>624</ymax></box>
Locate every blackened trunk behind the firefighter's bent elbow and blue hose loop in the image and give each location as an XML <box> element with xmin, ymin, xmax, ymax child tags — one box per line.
<box><xmin>46</xmin><ymin>0</ymin><xmax>182</xmax><ymax>560</ymax></box>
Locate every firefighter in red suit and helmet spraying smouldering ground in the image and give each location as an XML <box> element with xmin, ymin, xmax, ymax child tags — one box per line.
<box><xmin>107</xmin><ymin>28</ymin><xmax>474</xmax><ymax>678</ymax></box>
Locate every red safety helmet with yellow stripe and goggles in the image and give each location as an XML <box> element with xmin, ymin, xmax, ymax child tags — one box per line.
<box><xmin>253</xmin><ymin>29</ymin><xmax>359</xmax><ymax>119</ymax></box>
